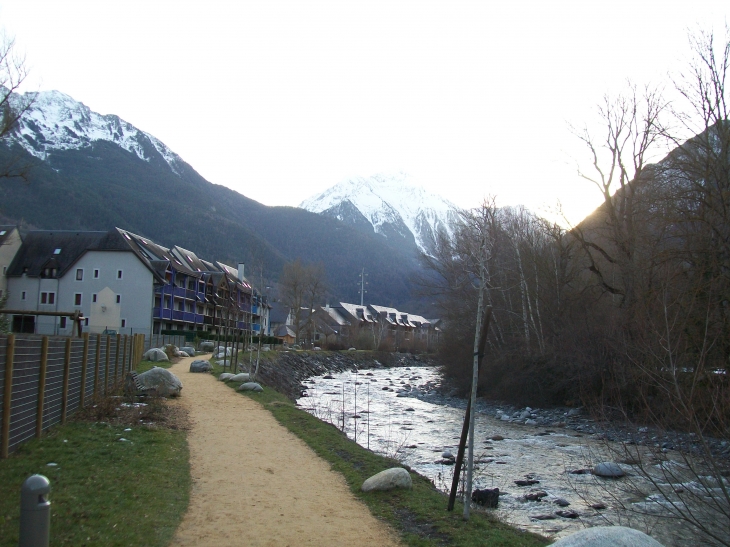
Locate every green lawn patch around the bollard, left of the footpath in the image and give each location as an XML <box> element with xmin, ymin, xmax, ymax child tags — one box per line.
<box><xmin>0</xmin><ymin>408</ymin><xmax>190</xmax><ymax>547</ymax></box>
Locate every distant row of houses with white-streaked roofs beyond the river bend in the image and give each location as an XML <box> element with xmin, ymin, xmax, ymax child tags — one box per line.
<box><xmin>272</xmin><ymin>302</ymin><xmax>441</xmax><ymax>351</ymax></box>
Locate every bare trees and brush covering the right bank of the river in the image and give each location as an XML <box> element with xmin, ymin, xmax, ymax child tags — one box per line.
<box><xmin>423</xmin><ymin>28</ymin><xmax>730</xmax><ymax>545</ymax></box>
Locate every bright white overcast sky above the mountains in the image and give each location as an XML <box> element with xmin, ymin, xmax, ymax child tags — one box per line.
<box><xmin>0</xmin><ymin>0</ymin><xmax>730</xmax><ymax>225</ymax></box>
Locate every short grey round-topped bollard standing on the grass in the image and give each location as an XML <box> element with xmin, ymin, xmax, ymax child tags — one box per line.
<box><xmin>18</xmin><ymin>475</ymin><xmax>51</xmax><ymax>547</ymax></box>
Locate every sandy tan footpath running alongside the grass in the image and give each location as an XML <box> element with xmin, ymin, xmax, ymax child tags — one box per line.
<box><xmin>170</xmin><ymin>358</ymin><xmax>398</xmax><ymax>547</ymax></box>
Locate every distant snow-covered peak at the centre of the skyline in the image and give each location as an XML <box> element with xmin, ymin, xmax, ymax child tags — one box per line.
<box><xmin>299</xmin><ymin>173</ymin><xmax>458</xmax><ymax>253</ymax></box>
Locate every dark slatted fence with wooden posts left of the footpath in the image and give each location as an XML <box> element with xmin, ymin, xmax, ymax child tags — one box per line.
<box><xmin>0</xmin><ymin>333</ymin><xmax>145</xmax><ymax>458</ymax></box>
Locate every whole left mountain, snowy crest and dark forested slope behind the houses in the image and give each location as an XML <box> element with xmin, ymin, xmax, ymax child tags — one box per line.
<box><xmin>0</xmin><ymin>92</ymin><xmax>418</xmax><ymax>312</ymax></box>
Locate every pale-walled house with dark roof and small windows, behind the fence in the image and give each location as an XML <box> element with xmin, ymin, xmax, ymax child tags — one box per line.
<box><xmin>6</xmin><ymin>230</ymin><xmax>156</xmax><ymax>336</ymax></box>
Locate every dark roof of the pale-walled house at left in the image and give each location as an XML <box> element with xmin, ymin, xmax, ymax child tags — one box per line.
<box><xmin>7</xmin><ymin>230</ymin><xmax>130</xmax><ymax>277</ymax></box>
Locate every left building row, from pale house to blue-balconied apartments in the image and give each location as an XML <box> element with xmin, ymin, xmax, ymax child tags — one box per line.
<box><xmin>0</xmin><ymin>226</ymin><xmax>270</xmax><ymax>336</ymax></box>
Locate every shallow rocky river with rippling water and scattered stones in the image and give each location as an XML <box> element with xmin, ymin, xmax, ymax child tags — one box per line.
<box><xmin>297</xmin><ymin>361</ymin><xmax>728</xmax><ymax>545</ymax></box>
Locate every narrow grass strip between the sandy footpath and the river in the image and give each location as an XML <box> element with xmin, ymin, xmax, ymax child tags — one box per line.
<box><xmin>214</xmin><ymin>365</ymin><xmax>548</xmax><ymax>547</ymax></box>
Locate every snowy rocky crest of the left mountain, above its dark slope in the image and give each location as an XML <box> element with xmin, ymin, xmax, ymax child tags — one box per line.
<box><xmin>8</xmin><ymin>91</ymin><xmax>184</xmax><ymax>174</ymax></box>
